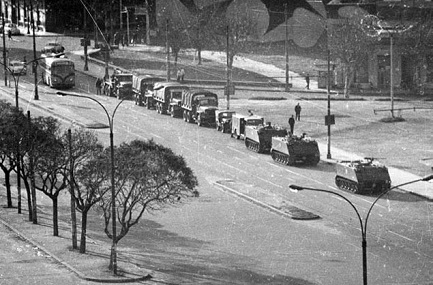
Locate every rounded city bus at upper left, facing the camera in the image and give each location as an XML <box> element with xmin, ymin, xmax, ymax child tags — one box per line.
<box><xmin>40</xmin><ymin>57</ymin><xmax>75</xmax><ymax>88</ymax></box>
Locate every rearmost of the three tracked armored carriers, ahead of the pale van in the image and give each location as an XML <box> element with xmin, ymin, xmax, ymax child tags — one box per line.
<box><xmin>245</xmin><ymin>123</ymin><xmax>287</xmax><ymax>153</ymax></box>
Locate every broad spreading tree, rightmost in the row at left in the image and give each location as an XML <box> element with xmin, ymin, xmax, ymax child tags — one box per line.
<box><xmin>100</xmin><ymin>140</ymin><xmax>198</xmax><ymax>269</ymax></box>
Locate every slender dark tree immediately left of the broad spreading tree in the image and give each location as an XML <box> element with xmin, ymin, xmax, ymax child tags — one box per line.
<box><xmin>63</xmin><ymin>129</ymin><xmax>110</xmax><ymax>253</ymax></box>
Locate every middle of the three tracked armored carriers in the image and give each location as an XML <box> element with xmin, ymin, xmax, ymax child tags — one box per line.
<box><xmin>271</xmin><ymin>136</ymin><xmax>320</xmax><ymax>166</ymax></box>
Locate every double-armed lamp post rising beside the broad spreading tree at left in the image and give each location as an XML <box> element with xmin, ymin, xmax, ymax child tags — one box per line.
<box><xmin>57</xmin><ymin>91</ymin><xmax>125</xmax><ymax>275</ymax></box>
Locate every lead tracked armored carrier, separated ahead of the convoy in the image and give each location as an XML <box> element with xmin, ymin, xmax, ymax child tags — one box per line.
<box><xmin>335</xmin><ymin>158</ymin><xmax>391</xmax><ymax>194</ymax></box>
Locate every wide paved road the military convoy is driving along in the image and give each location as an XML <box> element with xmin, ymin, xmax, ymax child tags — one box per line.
<box><xmin>0</xmin><ymin>34</ymin><xmax>433</xmax><ymax>284</ymax></box>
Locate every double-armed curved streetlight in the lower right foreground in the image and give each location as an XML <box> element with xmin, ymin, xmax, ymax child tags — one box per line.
<box><xmin>289</xmin><ymin>174</ymin><xmax>433</xmax><ymax>285</ymax></box>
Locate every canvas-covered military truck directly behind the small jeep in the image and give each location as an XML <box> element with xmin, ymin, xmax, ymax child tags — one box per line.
<box><xmin>181</xmin><ymin>89</ymin><xmax>218</xmax><ymax>126</ymax></box>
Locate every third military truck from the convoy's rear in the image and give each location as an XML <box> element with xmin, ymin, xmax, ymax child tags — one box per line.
<box><xmin>153</xmin><ymin>82</ymin><xmax>189</xmax><ymax>117</ymax></box>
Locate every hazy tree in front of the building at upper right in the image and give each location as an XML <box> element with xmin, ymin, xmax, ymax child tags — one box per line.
<box><xmin>328</xmin><ymin>18</ymin><xmax>376</xmax><ymax>98</ymax></box>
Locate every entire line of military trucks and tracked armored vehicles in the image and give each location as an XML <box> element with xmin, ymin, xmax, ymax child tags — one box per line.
<box><xmin>101</xmin><ymin>72</ymin><xmax>391</xmax><ymax>194</ymax></box>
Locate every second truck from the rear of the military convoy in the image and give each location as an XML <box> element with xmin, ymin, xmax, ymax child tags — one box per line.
<box><xmin>132</xmin><ymin>74</ymin><xmax>164</xmax><ymax>109</ymax></box>
